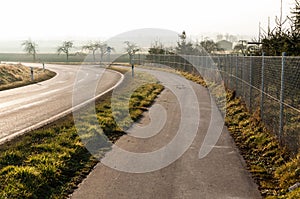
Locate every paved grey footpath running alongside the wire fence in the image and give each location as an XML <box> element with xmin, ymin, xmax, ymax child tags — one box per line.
<box><xmin>70</xmin><ymin>69</ymin><xmax>261</xmax><ymax>199</ymax></box>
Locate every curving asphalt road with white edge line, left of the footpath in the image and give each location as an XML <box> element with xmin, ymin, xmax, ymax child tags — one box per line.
<box><xmin>0</xmin><ymin>63</ymin><xmax>122</xmax><ymax>143</ymax></box>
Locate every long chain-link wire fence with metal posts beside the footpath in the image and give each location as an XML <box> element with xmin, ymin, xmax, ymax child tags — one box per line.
<box><xmin>135</xmin><ymin>53</ymin><xmax>300</xmax><ymax>154</ymax></box>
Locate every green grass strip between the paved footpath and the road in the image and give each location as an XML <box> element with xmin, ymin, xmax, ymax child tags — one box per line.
<box><xmin>0</xmin><ymin>67</ymin><xmax>163</xmax><ymax>198</ymax></box>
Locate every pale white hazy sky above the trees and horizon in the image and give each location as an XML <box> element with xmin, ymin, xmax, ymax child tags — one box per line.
<box><xmin>0</xmin><ymin>0</ymin><xmax>294</xmax><ymax>40</ymax></box>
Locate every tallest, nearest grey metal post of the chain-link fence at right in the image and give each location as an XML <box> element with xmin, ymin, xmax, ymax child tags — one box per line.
<box><xmin>278</xmin><ymin>52</ymin><xmax>285</xmax><ymax>141</ymax></box>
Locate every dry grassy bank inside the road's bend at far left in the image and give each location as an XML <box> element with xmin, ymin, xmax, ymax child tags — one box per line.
<box><xmin>0</xmin><ymin>64</ymin><xmax>56</xmax><ymax>91</ymax></box>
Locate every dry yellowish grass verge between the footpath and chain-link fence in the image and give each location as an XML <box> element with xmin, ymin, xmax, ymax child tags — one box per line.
<box><xmin>180</xmin><ymin>72</ymin><xmax>300</xmax><ymax>199</ymax></box>
